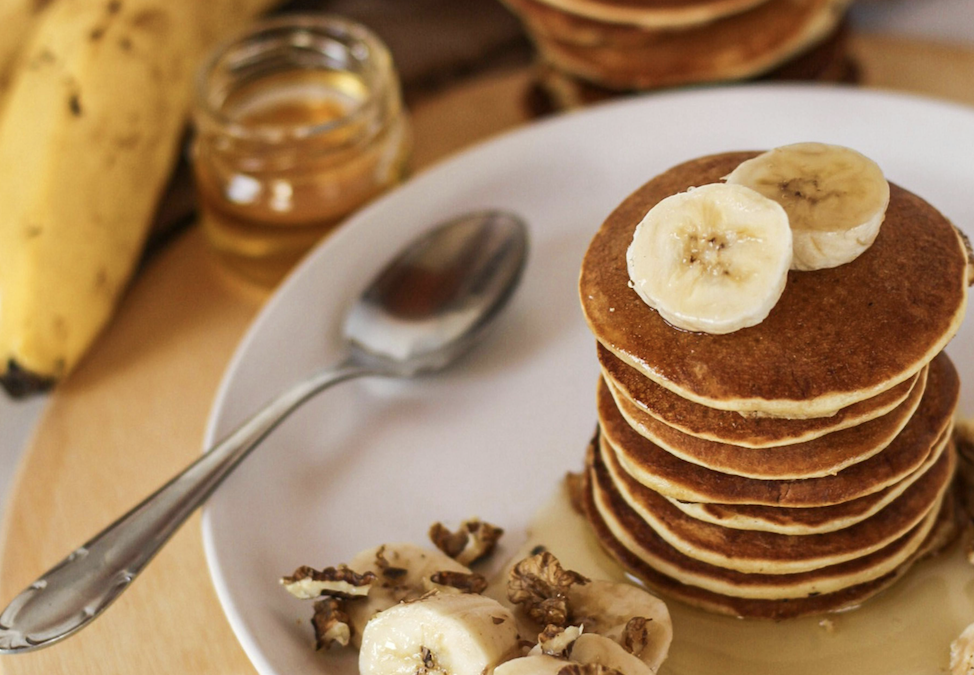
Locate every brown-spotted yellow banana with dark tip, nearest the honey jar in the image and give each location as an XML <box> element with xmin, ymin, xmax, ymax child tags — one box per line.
<box><xmin>0</xmin><ymin>0</ymin><xmax>272</xmax><ymax>395</ymax></box>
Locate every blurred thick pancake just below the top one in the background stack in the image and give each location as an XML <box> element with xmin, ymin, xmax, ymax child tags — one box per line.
<box><xmin>505</xmin><ymin>0</ymin><xmax>849</xmax><ymax>90</ymax></box>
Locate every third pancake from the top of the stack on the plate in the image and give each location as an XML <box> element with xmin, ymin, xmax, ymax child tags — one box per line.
<box><xmin>598</xmin><ymin>364</ymin><xmax>926</xmax><ymax>480</ymax></box>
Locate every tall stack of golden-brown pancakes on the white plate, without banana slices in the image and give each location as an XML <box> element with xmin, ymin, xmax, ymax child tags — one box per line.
<box><xmin>579</xmin><ymin>153</ymin><xmax>974</xmax><ymax>618</ymax></box>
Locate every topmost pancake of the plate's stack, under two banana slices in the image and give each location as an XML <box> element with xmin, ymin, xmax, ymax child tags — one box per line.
<box><xmin>579</xmin><ymin>152</ymin><xmax>968</xmax><ymax>418</ymax></box>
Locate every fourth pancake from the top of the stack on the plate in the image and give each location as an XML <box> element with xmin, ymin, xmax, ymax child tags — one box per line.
<box><xmin>598</xmin><ymin>354</ymin><xmax>960</xmax><ymax>507</ymax></box>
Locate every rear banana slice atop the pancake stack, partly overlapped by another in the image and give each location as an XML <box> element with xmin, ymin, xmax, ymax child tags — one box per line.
<box><xmin>726</xmin><ymin>143</ymin><xmax>889</xmax><ymax>270</ymax></box>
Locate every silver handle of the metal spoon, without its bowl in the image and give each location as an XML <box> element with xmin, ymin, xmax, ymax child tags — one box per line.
<box><xmin>0</xmin><ymin>358</ymin><xmax>384</xmax><ymax>653</ymax></box>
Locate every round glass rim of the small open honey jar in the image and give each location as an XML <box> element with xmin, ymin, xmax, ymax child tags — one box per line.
<box><xmin>194</xmin><ymin>13</ymin><xmax>398</xmax><ymax>142</ymax></box>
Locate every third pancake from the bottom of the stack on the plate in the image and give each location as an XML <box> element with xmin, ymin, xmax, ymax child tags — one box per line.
<box><xmin>591</xmin><ymin>426</ymin><xmax>956</xmax><ymax>575</ymax></box>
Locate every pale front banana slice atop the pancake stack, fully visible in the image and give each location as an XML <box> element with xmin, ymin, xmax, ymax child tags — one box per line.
<box><xmin>626</xmin><ymin>183</ymin><xmax>792</xmax><ymax>334</ymax></box>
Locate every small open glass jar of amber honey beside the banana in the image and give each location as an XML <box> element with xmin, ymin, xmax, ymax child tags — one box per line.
<box><xmin>193</xmin><ymin>15</ymin><xmax>411</xmax><ymax>286</ymax></box>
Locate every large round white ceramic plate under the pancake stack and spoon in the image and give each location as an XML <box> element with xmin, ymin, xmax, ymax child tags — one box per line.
<box><xmin>204</xmin><ymin>86</ymin><xmax>974</xmax><ymax>675</ymax></box>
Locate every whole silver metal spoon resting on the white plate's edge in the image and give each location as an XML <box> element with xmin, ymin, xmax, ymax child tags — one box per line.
<box><xmin>0</xmin><ymin>212</ymin><xmax>527</xmax><ymax>653</ymax></box>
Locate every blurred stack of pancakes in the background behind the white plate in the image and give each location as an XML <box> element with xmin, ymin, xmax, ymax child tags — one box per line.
<box><xmin>503</xmin><ymin>0</ymin><xmax>851</xmax><ymax>107</ymax></box>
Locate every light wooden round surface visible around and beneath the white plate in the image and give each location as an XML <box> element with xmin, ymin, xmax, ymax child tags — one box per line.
<box><xmin>0</xmin><ymin>36</ymin><xmax>974</xmax><ymax>675</ymax></box>
